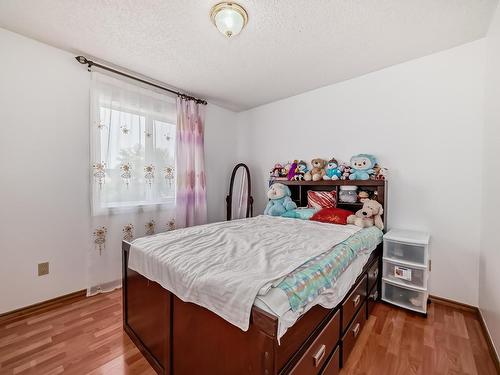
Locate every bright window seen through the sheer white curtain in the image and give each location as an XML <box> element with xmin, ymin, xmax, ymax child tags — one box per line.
<box><xmin>91</xmin><ymin>72</ymin><xmax>176</xmax><ymax>214</ymax></box>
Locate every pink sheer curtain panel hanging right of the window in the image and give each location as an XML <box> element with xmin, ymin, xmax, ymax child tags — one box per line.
<box><xmin>175</xmin><ymin>97</ymin><xmax>207</xmax><ymax>228</ymax></box>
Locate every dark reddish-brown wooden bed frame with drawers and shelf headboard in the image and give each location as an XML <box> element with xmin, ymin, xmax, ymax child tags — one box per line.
<box><xmin>122</xmin><ymin>180</ymin><xmax>387</xmax><ymax>375</ymax></box>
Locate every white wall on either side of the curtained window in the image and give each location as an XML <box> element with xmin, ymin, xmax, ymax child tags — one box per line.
<box><xmin>0</xmin><ymin>29</ymin><xmax>236</xmax><ymax>313</ymax></box>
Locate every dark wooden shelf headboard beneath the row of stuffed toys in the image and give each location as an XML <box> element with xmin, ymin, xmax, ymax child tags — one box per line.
<box><xmin>278</xmin><ymin>180</ymin><xmax>387</xmax><ymax>222</ymax></box>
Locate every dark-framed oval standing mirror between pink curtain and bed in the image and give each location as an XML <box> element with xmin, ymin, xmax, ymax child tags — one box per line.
<box><xmin>226</xmin><ymin>163</ymin><xmax>253</xmax><ymax>220</ymax></box>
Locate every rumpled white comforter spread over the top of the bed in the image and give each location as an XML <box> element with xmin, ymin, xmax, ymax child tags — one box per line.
<box><xmin>128</xmin><ymin>216</ymin><xmax>359</xmax><ymax>331</ymax></box>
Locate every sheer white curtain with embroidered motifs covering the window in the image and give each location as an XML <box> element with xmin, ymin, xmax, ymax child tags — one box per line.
<box><xmin>87</xmin><ymin>72</ymin><xmax>177</xmax><ymax>295</ymax></box>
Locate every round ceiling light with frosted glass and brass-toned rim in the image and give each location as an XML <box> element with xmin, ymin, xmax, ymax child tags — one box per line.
<box><xmin>210</xmin><ymin>2</ymin><xmax>248</xmax><ymax>38</ymax></box>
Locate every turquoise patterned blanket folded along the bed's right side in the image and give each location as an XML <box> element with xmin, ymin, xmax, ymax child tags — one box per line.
<box><xmin>277</xmin><ymin>227</ymin><xmax>383</xmax><ymax>311</ymax></box>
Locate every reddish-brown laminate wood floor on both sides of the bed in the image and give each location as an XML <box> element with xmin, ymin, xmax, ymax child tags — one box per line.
<box><xmin>0</xmin><ymin>291</ymin><xmax>496</xmax><ymax>375</ymax></box>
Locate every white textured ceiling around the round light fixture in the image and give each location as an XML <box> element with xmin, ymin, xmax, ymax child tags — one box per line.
<box><xmin>0</xmin><ymin>0</ymin><xmax>497</xmax><ymax>110</ymax></box>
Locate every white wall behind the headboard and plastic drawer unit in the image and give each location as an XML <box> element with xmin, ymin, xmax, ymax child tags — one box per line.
<box><xmin>238</xmin><ymin>40</ymin><xmax>484</xmax><ymax>306</ymax></box>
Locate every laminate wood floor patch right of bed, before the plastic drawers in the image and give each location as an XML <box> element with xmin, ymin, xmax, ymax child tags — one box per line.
<box><xmin>341</xmin><ymin>303</ymin><xmax>497</xmax><ymax>375</ymax></box>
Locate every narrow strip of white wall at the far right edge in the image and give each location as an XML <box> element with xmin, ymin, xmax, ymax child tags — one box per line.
<box><xmin>479</xmin><ymin>2</ymin><xmax>500</xmax><ymax>353</ymax></box>
